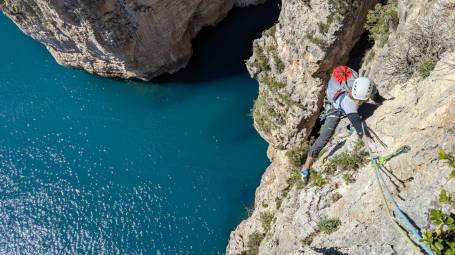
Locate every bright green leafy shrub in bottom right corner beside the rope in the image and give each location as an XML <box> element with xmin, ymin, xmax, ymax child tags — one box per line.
<box><xmin>423</xmin><ymin>190</ymin><xmax>455</xmax><ymax>255</ymax></box>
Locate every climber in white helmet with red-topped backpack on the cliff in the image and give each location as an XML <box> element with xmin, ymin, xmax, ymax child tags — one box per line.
<box><xmin>300</xmin><ymin>66</ymin><xmax>375</xmax><ymax>183</ymax></box>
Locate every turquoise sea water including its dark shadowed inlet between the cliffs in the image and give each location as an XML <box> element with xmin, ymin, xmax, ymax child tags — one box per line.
<box><xmin>0</xmin><ymin>3</ymin><xmax>277</xmax><ymax>254</ymax></box>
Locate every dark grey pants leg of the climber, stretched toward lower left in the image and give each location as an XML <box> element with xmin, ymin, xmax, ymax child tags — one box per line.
<box><xmin>308</xmin><ymin>111</ymin><xmax>342</xmax><ymax>158</ymax></box>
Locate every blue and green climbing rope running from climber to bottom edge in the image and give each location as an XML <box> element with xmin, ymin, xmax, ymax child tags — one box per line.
<box><xmin>362</xmin><ymin>122</ymin><xmax>434</xmax><ymax>255</ymax></box>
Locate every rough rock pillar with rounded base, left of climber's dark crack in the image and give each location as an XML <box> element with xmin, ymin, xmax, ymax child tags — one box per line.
<box><xmin>247</xmin><ymin>0</ymin><xmax>377</xmax><ymax>149</ymax></box>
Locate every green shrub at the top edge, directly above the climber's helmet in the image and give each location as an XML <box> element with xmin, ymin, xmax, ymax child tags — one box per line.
<box><xmin>365</xmin><ymin>0</ymin><xmax>399</xmax><ymax>44</ymax></box>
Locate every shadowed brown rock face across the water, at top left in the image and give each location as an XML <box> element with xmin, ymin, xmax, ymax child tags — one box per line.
<box><xmin>0</xmin><ymin>0</ymin><xmax>264</xmax><ymax>80</ymax></box>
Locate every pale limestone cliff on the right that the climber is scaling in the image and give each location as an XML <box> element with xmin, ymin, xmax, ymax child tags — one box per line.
<box><xmin>230</xmin><ymin>0</ymin><xmax>455</xmax><ymax>254</ymax></box>
